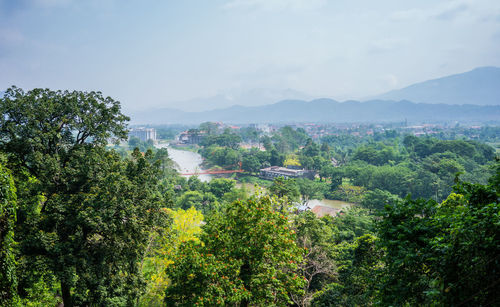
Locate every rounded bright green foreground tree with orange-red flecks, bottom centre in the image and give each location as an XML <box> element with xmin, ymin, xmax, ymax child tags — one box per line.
<box><xmin>166</xmin><ymin>197</ymin><xmax>304</xmax><ymax>306</ymax></box>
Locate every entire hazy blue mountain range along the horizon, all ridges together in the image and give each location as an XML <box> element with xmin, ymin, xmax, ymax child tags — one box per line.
<box><xmin>131</xmin><ymin>67</ymin><xmax>500</xmax><ymax>124</ymax></box>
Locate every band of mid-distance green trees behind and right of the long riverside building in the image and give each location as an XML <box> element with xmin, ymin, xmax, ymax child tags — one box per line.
<box><xmin>196</xmin><ymin>122</ymin><xmax>496</xmax><ymax>203</ymax></box>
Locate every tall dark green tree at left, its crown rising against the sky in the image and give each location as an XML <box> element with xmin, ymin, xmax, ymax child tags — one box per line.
<box><xmin>0</xmin><ymin>87</ymin><xmax>168</xmax><ymax>306</ymax></box>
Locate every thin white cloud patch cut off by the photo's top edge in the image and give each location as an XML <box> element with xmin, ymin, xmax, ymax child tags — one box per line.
<box><xmin>223</xmin><ymin>0</ymin><xmax>326</xmax><ymax>11</ymax></box>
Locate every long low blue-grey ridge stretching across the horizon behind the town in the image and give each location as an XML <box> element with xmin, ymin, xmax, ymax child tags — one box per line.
<box><xmin>129</xmin><ymin>99</ymin><xmax>500</xmax><ymax>124</ymax></box>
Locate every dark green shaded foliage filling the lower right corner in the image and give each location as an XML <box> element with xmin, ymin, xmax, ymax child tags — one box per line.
<box><xmin>379</xmin><ymin>166</ymin><xmax>500</xmax><ymax>306</ymax></box>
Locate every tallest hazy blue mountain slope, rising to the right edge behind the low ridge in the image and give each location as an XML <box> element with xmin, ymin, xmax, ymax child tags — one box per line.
<box><xmin>375</xmin><ymin>67</ymin><xmax>500</xmax><ymax>105</ymax></box>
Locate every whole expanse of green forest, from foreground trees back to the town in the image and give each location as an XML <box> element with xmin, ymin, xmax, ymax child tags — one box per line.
<box><xmin>0</xmin><ymin>87</ymin><xmax>500</xmax><ymax>306</ymax></box>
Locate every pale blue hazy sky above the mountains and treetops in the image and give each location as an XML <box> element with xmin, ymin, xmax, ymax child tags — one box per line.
<box><xmin>0</xmin><ymin>0</ymin><xmax>500</xmax><ymax>109</ymax></box>
